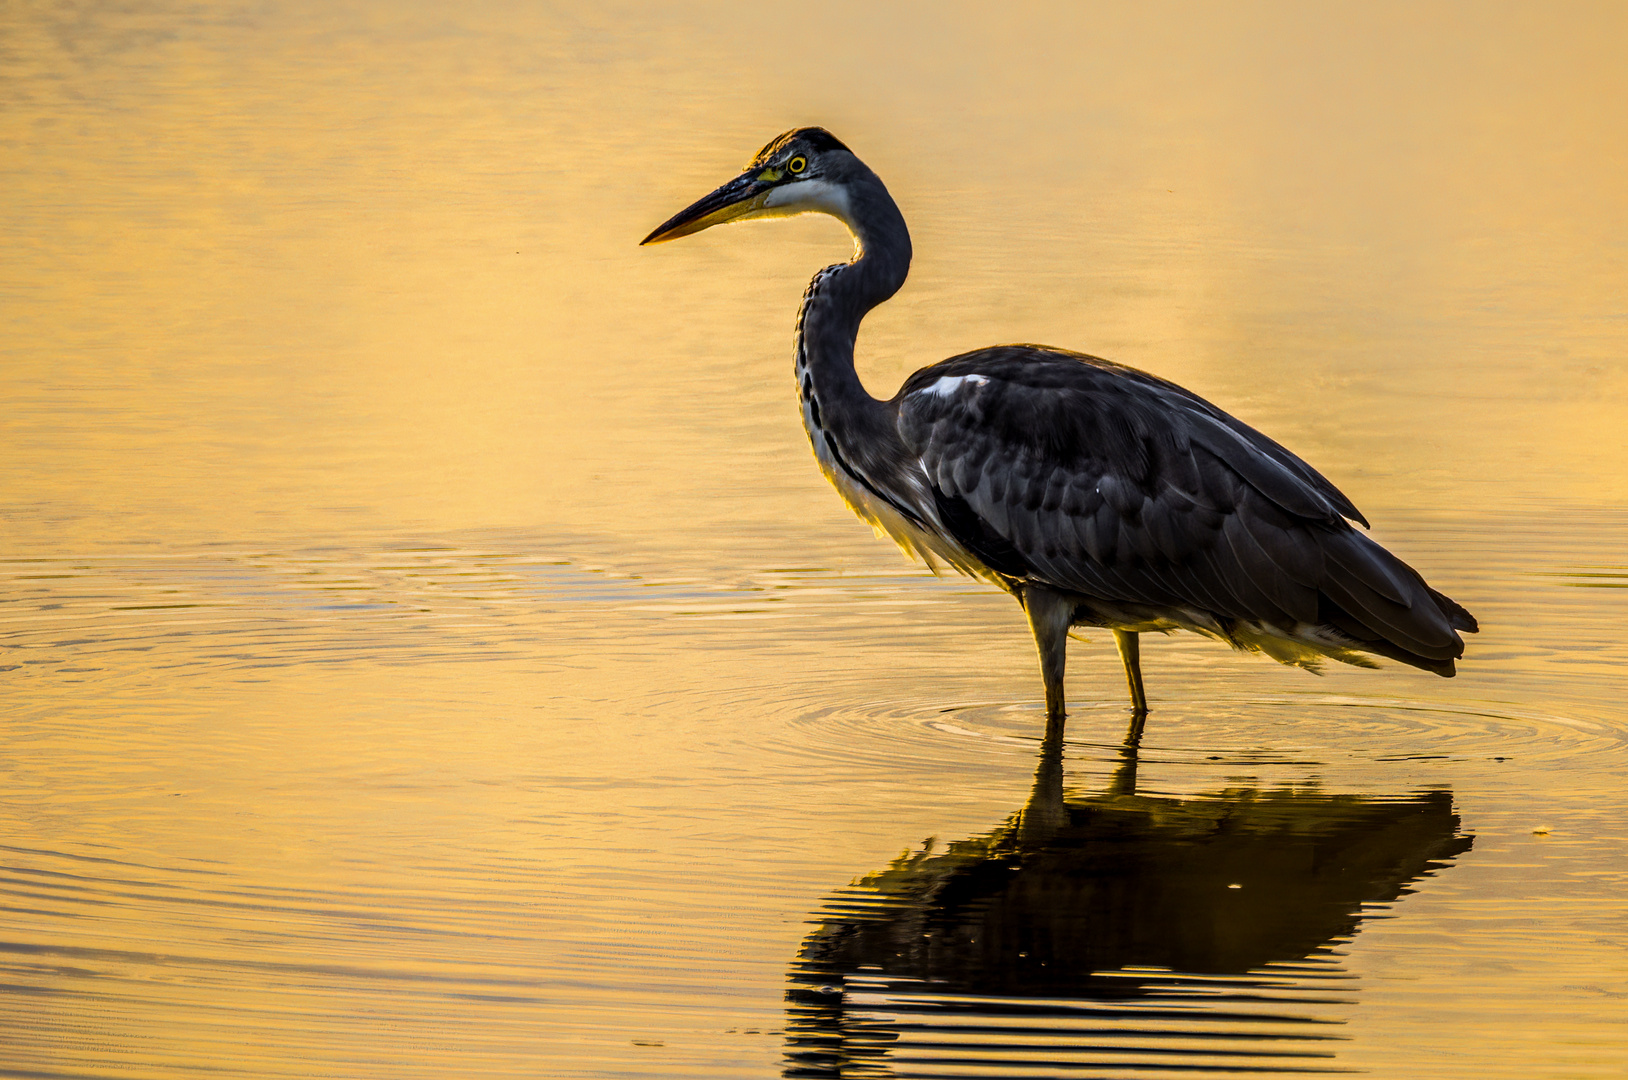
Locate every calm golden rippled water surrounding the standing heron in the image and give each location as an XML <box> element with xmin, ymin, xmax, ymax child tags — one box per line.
<box><xmin>0</xmin><ymin>2</ymin><xmax>1628</xmax><ymax>1080</ymax></box>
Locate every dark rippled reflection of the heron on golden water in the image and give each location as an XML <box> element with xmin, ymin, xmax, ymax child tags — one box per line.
<box><xmin>785</xmin><ymin>731</ymin><xmax>1472</xmax><ymax>1077</ymax></box>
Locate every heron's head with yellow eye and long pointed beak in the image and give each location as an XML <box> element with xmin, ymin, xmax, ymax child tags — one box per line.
<box><xmin>640</xmin><ymin>127</ymin><xmax>858</xmax><ymax>244</ymax></box>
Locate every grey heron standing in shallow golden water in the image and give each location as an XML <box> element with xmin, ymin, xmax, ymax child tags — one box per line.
<box><xmin>641</xmin><ymin>127</ymin><xmax>1477</xmax><ymax>738</ymax></box>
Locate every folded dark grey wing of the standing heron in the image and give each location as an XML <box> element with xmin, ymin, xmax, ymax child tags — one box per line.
<box><xmin>894</xmin><ymin>345</ymin><xmax>1475</xmax><ymax>673</ymax></box>
